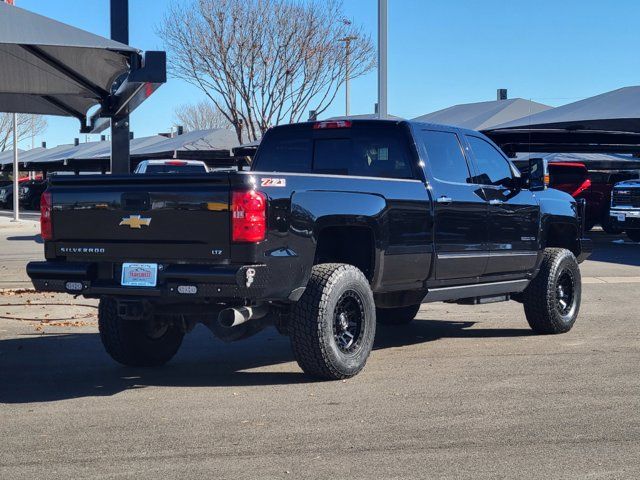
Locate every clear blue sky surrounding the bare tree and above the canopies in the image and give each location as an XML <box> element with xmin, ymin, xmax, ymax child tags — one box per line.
<box><xmin>16</xmin><ymin>0</ymin><xmax>640</xmax><ymax>147</ymax></box>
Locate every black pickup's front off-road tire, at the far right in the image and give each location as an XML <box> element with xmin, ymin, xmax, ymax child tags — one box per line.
<box><xmin>522</xmin><ymin>248</ymin><xmax>582</xmax><ymax>334</ymax></box>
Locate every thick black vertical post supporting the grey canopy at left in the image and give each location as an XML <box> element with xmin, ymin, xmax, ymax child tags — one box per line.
<box><xmin>111</xmin><ymin>0</ymin><xmax>130</xmax><ymax>174</ymax></box>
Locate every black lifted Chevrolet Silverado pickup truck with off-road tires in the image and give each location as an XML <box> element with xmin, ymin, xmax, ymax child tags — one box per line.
<box><xmin>27</xmin><ymin>120</ymin><xmax>589</xmax><ymax>379</ymax></box>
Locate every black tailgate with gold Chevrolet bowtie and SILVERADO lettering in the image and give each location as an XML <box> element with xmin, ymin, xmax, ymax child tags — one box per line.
<box><xmin>49</xmin><ymin>173</ymin><xmax>230</xmax><ymax>263</ymax></box>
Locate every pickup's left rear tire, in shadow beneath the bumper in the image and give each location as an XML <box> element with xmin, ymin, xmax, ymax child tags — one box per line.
<box><xmin>98</xmin><ymin>298</ymin><xmax>184</xmax><ymax>367</ymax></box>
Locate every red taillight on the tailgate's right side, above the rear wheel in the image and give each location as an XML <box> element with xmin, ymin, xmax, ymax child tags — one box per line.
<box><xmin>231</xmin><ymin>190</ymin><xmax>267</xmax><ymax>242</ymax></box>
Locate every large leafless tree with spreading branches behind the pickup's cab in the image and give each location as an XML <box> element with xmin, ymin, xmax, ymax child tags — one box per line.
<box><xmin>158</xmin><ymin>0</ymin><xmax>375</xmax><ymax>141</ymax></box>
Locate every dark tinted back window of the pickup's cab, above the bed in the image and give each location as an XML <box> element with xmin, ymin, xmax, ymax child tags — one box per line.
<box><xmin>253</xmin><ymin>123</ymin><xmax>413</xmax><ymax>178</ymax></box>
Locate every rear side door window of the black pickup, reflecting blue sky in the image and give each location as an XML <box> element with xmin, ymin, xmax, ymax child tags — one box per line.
<box><xmin>418</xmin><ymin>130</ymin><xmax>471</xmax><ymax>183</ymax></box>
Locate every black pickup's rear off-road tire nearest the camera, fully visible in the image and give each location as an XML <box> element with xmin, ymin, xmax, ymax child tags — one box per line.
<box><xmin>289</xmin><ymin>263</ymin><xmax>376</xmax><ymax>380</ymax></box>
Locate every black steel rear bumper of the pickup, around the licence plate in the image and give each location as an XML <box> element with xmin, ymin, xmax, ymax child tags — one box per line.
<box><xmin>27</xmin><ymin>262</ymin><xmax>268</xmax><ymax>300</ymax></box>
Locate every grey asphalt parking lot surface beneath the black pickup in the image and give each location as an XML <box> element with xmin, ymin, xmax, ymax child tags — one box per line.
<box><xmin>0</xmin><ymin>223</ymin><xmax>640</xmax><ymax>479</ymax></box>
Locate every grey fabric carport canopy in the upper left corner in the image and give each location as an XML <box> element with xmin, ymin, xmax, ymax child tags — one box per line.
<box><xmin>0</xmin><ymin>2</ymin><xmax>139</xmax><ymax>123</ymax></box>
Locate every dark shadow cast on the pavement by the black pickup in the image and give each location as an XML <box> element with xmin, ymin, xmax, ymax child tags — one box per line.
<box><xmin>0</xmin><ymin>320</ymin><xmax>531</xmax><ymax>404</ymax></box>
